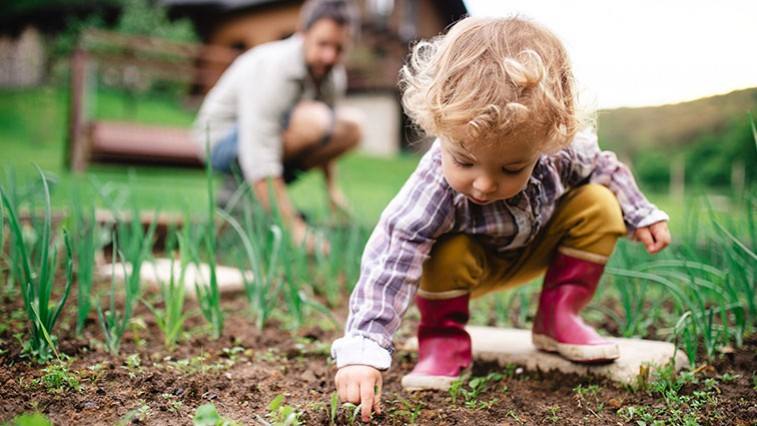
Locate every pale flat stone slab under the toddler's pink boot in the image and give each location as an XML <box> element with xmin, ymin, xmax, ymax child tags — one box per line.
<box><xmin>400</xmin><ymin>326</ymin><xmax>689</xmax><ymax>384</ymax></box>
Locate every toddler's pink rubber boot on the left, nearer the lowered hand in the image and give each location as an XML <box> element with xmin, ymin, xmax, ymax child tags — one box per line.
<box><xmin>402</xmin><ymin>294</ymin><xmax>472</xmax><ymax>390</ymax></box>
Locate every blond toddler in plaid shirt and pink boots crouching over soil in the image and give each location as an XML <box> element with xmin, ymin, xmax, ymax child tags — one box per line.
<box><xmin>332</xmin><ymin>18</ymin><xmax>670</xmax><ymax>421</ymax></box>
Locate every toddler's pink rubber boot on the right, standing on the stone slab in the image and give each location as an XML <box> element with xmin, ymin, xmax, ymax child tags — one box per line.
<box><xmin>532</xmin><ymin>253</ymin><xmax>620</xmax><ymax>363</ymax></box>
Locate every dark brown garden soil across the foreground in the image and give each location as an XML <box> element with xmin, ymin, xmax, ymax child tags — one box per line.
<box><xmin>0</xmin><ymin>286</ymin><xmax>757</xmax><ymax>426</ymax></box>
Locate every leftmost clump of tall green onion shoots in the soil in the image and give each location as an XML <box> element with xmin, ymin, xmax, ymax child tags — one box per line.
<box><xmin>0</xmin><ymin>167</ymin><xmax>73</xmax><ymax>362</ymax></box>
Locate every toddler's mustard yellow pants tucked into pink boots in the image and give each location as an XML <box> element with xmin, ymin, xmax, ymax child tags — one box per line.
<box><xmin>418</xmin><ymin>184</ymin><xmax>626</xmax><ymax>299</ymax></box>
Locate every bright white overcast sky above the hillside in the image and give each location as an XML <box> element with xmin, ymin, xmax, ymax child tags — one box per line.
<box><xmin>465</xmin><ymin>0</ymin><xmax>757</xmax><ymax>109</ymax></box>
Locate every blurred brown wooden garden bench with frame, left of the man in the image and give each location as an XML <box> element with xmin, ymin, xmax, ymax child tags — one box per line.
<box><xmin>66</xmin><ymin>30</ymin><xmax>239</xmax><ymax>172</ymax></box>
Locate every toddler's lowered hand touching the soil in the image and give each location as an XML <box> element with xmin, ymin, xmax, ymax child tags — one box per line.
<box><xmin>334</xmin><ymin>365</ymin><xmax>381</xmax><ymax>422</ymax></box>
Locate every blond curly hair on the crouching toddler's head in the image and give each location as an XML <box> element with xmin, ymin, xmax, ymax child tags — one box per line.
<box><xmin>400</xmin><ymin>17</ymin><xmax>585</xmax><ymax>152</ymax></box>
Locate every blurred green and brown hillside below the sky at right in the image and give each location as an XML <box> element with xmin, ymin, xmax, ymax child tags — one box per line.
<box><xmin>598</xmin><ymin>88</ymin><xmax>757</xmax><ymax>191</ymax></box>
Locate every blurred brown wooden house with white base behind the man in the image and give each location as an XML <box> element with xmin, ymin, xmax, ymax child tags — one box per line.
<box><xmin>159</xmin><ymin>0</ymin><xmax>467</xmax><ymax>155</ymax></box>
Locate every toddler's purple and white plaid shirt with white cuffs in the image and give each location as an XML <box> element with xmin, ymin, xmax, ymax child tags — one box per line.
<box><xmin>332</xmin><ymin>131</ymin><xmax>668</xmax><ymax>370</ymax></box>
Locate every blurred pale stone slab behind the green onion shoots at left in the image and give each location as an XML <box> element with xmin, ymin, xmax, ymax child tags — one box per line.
<box><xmin>97</xmin><ymin>258</ymin><xmax>252</xmax><ymax>298</ymax></box>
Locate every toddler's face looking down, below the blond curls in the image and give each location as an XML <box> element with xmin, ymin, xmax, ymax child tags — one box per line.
<box><xmin>442</xmin><ymin>139</ymin><xmax>540</xmax><ymax>205</ymax></box>
